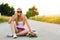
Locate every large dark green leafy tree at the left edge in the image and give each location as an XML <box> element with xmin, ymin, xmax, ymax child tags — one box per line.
<box><xmin>0</xmin><ymin>3</ymin><xmax>15</xmax><ymax>16</ymax></box>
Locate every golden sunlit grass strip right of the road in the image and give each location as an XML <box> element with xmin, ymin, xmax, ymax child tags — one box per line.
<box><xmin>29</xmin><ymin>16</ymin><xmax>60</xmax><ymax>24</ymax></box>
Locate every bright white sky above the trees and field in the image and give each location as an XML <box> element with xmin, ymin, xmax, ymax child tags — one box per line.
<box><xmin>0</xmin><ymin>0</ymin><xmax>60</xmax><ymax>15</ymax></box>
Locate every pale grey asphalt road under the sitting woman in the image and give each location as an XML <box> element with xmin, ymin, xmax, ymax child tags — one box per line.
<box><xmin>0</xmin><ymin>20</ymin><xmax>60</xmax><ymax>40</ymax></box>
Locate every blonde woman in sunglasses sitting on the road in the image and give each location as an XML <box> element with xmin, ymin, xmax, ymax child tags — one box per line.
<box><xmin>8</xmin><ymin>8</ymin><xmax>32</xmax><ymax>38</ymax></box>
